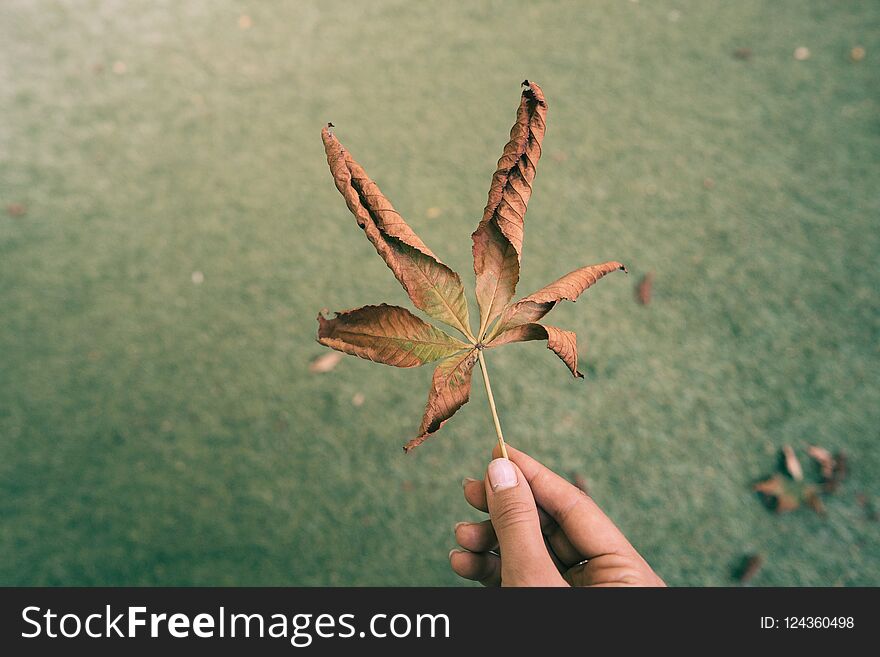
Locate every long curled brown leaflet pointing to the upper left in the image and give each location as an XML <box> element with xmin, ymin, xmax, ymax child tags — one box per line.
<box><xmin>321</xmin><ymin>125</ymin><xmax>471</xmax><ymax>338</ymax></box>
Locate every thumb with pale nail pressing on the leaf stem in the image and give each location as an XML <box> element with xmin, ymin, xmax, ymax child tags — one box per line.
<box><xmin>485</xmin><ymin>458</ymin><xmax>566</xmax><ymax>586</ymax></box>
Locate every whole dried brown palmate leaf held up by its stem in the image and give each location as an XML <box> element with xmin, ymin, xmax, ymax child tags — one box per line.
<box><xmin>318</xmin><ymin>81</ymin><xmax>626</xmax><ymax>451</ymax></box>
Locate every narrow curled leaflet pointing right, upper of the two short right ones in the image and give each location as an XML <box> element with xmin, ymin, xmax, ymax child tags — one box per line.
<box><xmin>486</xmin><ymin>261</ymin><xmax>626</xmax><ymax>342</ymax></box>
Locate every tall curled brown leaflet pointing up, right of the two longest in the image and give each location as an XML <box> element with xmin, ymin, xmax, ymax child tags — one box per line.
<box><xmin>471</xmin><ymin>80</ymin><xmax>547</xmax><ymax>335</ymax></box>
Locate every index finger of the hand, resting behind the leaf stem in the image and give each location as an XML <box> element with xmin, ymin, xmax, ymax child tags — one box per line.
<box><xmin>493</xmin><ymin>445</ymin><xmax>635</xmax><ymax>559</ymax></box>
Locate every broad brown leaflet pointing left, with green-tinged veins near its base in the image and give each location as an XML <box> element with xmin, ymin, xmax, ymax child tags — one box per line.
<box><xmin>318</xmin><ymin>303</ymin><xmax>468</xmax><ymax>367</ymax></box>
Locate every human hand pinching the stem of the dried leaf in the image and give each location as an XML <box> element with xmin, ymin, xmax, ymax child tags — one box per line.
<box><xmin>449</xmin><ymin>445</ymin><xmax>665</xmax><ymax>586</ymax></box>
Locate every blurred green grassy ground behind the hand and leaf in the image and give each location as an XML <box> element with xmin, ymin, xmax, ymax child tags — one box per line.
<box><xmin>0</xmin><ymin>0</ymin><xmax>880</xmax><ymax>585</ymax></box>
